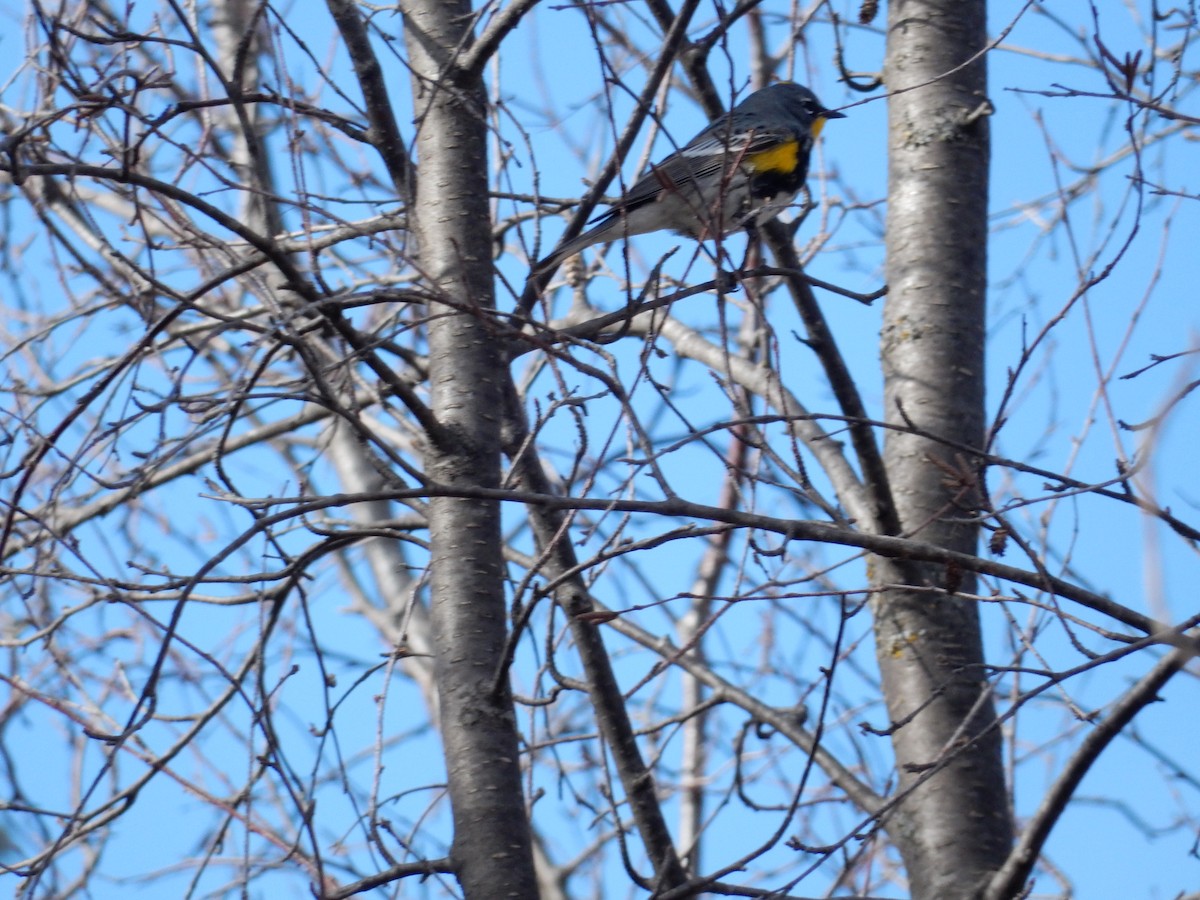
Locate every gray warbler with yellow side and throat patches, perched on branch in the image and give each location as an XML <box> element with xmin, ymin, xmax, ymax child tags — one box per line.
<box><xmin>533</xmin><ymin>82</ymin><xmax>846</xmax><ymax>275</ymax></box>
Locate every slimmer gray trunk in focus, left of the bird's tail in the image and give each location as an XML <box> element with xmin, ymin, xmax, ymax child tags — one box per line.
<box><xmin>403</xmin><ymin>0</ymin><xmax>538</xmax><ymax>900</ymax></box>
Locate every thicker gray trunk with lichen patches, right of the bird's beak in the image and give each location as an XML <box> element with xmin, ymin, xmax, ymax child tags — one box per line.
<box><xmin>874</xmin><ymin>0</ymin><xmax>1013</xmax><ymax>900</ymax></box>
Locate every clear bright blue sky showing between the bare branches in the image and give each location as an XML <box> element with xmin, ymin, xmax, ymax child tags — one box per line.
<box><xmin>0</xmin><ymin>2</ymin><xmax>1200</xmax><ymax>898</ymax></box>
